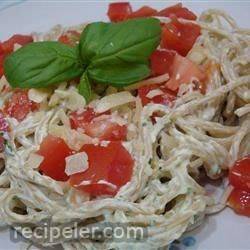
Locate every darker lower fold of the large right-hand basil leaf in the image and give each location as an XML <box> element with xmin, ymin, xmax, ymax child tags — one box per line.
<box><xmin>88</xmin><ymin>62</ymin><xmax>150</xmax><ymax>87</ymax></box>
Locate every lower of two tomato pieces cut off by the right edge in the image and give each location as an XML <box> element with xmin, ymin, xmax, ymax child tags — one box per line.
<box><xmin>228</xmin><ymin>188</ymin><xmax>250</xmax><ymax>217</ymax></box>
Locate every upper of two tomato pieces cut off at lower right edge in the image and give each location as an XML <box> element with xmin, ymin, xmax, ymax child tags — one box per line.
<box><xmin>229</xmin><ymin>155</ymin><xmax>250</xmax><ymax>192</ymax></box>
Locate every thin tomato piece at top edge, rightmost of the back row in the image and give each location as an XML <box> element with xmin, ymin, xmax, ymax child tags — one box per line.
<box><xmin>157</xmin><ymin>3</ymin><xmax>197</xmax><ymax>20</ymax></box>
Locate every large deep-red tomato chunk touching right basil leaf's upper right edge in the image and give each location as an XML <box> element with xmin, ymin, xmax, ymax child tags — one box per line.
<box><xmin>161</xmin><ymin>18</ymin><xmax>200</xmax><ymax>56</ymax></box>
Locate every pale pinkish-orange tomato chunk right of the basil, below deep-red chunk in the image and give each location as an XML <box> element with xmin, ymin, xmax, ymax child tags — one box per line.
<box><xmin>166</xmin><ymin>54</ymin><xmax>206</xmax><ymax>93</ymax></box>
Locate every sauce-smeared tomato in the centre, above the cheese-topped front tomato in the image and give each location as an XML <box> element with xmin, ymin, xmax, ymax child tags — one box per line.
<box><xmin>70</xmin><ymin>108</ymin><xmax>127</xmax><ymax>141</ymax></box>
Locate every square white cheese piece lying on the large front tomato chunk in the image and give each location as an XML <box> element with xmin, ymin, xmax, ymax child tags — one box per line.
<box><xmin>65</xmin><ymin>152</ymin><xmax>89</xmax><ymax>176</ymax></box>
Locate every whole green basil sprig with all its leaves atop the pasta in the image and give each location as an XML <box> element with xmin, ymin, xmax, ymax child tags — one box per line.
<box><xmin>4</xmin><ymin>18</ymin><xmax>161</xmax><ymax>101</ymax></box>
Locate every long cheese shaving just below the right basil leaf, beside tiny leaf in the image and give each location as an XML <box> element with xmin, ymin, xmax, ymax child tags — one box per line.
<box><xmin>95</xmin><ymin>91</ymin><xmax>135</xmax><ymax>113</ymax></box>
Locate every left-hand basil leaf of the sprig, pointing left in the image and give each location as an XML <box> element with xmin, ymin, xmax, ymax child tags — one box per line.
<box><xmin>4</xmin><ymin>42</ymin><xmax>84</xmax><ymax>88</ymax></box>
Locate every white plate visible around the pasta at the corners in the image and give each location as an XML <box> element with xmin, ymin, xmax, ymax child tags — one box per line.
<box><xmin>0</xmin><ymin>0</ymin><xmax>250</xmax><ymax>250</ymax></box>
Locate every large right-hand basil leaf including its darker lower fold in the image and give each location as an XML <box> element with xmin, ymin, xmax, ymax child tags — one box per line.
<box><xmin>79</xmin><ymin>18</ymin><xmax>161</xmax><ymax>86</ymax></box>
